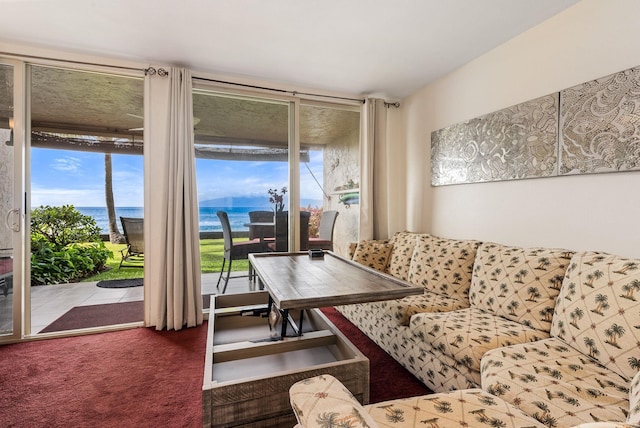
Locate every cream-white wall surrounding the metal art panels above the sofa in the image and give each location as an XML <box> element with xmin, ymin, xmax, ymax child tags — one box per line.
<box><xmin>391</xmin><ymin>0</ymin><xmax>640</xmax><ymax>258</ymax></box>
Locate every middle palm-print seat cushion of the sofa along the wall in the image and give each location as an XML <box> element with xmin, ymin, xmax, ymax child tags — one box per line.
<box><xmin>409</xmin><ymin>308</ymin><xmax>549</xmax><ymax>371</ymax></box>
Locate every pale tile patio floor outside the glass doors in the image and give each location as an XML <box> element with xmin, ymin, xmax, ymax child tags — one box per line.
<box><xmin>0</xmin><ymin>272</ymin><xmax>255</xmax><ymax>334</ymax></box>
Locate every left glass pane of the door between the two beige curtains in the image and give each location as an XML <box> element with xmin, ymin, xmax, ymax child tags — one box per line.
<box><xmin>193</xmin><ymin>90</ymin><xmax>290</xmax><ymax>298</ymax></box>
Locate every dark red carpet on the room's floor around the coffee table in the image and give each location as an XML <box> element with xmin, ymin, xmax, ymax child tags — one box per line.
<box><xmin>0</xmin><ymin>308</ymin><xmax>428</xmax><ymax>428</ymax></box>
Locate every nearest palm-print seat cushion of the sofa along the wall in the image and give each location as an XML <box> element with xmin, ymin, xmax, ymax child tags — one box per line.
<box><xmin>481</xmin><ymin>338</ymin><xmax>629</xmax><ymax>427</ymax></box>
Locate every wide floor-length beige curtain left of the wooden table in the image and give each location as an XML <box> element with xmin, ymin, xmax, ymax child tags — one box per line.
<box><xmin>144</xmin><ymin>67</ymin><xmax>202</xmax><ymax>330</ymax></box>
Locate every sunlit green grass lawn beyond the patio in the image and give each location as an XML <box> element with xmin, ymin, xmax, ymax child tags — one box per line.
<box><xmin>83</xmin><ymin>239</ymin><xmax>249</xmax><ymax>282</ymax></box>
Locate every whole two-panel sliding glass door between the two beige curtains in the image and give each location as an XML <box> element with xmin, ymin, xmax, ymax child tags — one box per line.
<box><xmin>193</xmin><ymin>83</ymin><xmax>360</xmax><ymax>298</ymax></box>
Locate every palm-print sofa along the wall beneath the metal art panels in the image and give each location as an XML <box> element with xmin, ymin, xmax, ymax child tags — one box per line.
<box><xmin>338</xmin><ymin>232</ymin><xmax>640</xmax><ymax>427</ymax></box>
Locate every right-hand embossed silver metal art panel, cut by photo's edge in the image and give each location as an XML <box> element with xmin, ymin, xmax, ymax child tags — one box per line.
<box><xmin>559</xmin><ymin>67</ymin><xmax>640</xmax><ymax>175</ymax></box>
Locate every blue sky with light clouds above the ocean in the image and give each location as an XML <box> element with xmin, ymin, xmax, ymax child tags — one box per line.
<box><xmin>31</xmin><ymin>148</ymin><xmax>323</xmax><ymax>207</ymax></box>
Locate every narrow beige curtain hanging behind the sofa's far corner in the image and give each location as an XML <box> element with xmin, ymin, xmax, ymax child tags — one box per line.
<box><xmin>359</xmin><ymin>98</ymin><xmax>396</xmax><ymax>239</ymax></box>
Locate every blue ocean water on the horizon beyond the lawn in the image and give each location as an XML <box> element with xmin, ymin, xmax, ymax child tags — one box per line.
<box><xmin>76</xmin><ymin>207</ymin><xmax>269</xmax><ymax>233</ymax></box>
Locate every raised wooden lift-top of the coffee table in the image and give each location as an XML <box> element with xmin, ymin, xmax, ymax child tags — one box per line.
<box><xmin>249</xmin><ymin>251</ymin><xmax>424</xmax><ymax>309</ymax></box>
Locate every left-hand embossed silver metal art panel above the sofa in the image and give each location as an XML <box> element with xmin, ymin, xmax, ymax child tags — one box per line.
<box><xmin>431</xmin><ymin>93</ymin><xmax>559</xmax><ymax>186</ymax></box>
